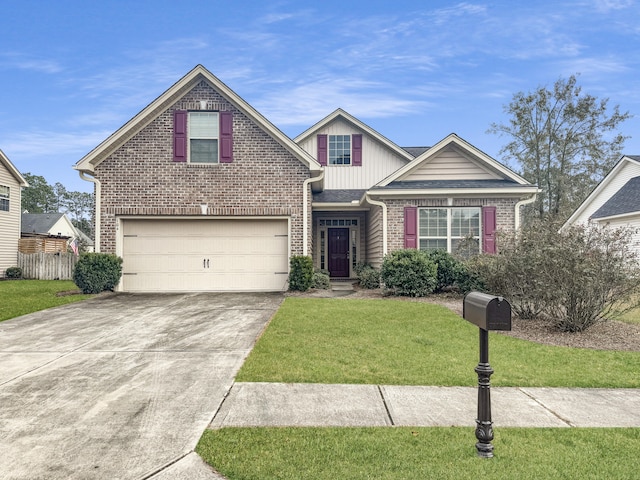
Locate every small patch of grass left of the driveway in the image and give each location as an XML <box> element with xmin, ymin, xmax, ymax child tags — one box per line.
<box><xmin>0</xmin><ymin>280</ymin><xmax>91</xmax><ymax>321</ymax></box>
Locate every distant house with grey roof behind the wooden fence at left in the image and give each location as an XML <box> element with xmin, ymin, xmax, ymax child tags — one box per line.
<box><xmin>19</xmin><ymin>213</ymin><xmax>79</xmax><ymax>253</ymax></box>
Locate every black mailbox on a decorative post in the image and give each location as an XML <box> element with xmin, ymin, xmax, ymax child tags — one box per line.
<box><xmin>462</xmin><ymin>292</ymin><xmax>511</xmax><ymax>458</ymax></box>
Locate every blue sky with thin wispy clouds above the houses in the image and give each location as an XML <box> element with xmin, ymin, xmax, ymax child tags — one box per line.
<box><xmin>0</xmin><ymin>0</ymin><xmax>640</xmax><ymax>191</ymax></box>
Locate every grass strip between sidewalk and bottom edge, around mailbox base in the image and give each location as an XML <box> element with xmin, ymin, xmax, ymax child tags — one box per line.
<box><xmin>196</xmin><ymin>427</ymin><xmax>640</xmax><ymax>480</ymax></box>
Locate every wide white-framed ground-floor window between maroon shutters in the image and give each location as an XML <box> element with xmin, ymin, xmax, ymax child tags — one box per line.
<box><xmin>418</xmin><ymin>207</ymin><xmax>480</xmax><ymax>252</ymax></box>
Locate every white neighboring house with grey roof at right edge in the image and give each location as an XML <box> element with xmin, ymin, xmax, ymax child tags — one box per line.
<box><xmin>563</xmin><ymin>155</ymin><xmax>640</xmax><ymax>254</ymax></box>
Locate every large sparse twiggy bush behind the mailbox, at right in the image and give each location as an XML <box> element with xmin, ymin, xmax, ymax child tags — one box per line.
<box><xmin>476</xmin><ymin>222</ymin><xmax>640</xmax><ymax>332</ymax></box>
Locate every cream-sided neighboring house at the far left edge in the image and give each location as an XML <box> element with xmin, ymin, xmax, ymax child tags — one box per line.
<box><xmin>0</xmin><ymin>150</ymin><xmax>29</xmax><ymax>278</ymax></box>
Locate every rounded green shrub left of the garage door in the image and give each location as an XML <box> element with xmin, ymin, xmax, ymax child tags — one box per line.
<box><xmin>73</xmin><ymin>253</ymin><xmax>122</xmax><ymax>293</ymax></box>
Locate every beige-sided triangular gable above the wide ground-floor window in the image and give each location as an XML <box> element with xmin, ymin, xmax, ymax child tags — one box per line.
<box><xmin>377</xmin><ymin>133</ymin><xmax>531</xmax><ymax>187</ymax></box>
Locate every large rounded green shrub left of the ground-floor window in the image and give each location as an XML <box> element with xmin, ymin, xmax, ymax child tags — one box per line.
<box><xmin>380</xmin><ymin>249</ymin><xmax>438</xmax><ymax>297</ymax></box>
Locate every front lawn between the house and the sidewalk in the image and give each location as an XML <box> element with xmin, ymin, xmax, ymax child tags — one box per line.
<box><xmin>237</xmin><ymin>297</ymin><xmax>640</xmax><ymax>388</ymax></box>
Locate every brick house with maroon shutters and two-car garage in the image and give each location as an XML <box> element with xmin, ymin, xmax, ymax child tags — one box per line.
<box><xmin>74</xmin><ymin>65</ymin><xmax>538</xmax><ymax>291</ymax></box>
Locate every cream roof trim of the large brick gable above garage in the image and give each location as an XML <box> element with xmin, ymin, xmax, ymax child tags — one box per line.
<box><xmin>74</xmin><ymin>65</ymin><xmax>321</xmax><ymax>172</ymax></box>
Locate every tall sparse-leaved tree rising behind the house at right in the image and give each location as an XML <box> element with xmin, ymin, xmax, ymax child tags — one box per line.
<box><xmin>489</xmin><ymin>75</ymin><xmax>631</xmax><ymax>218</ymax></box>
